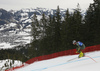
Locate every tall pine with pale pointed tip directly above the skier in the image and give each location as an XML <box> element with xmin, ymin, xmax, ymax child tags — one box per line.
<box><xmin>73</xmin><ymin>4</ymin><xmax>82</xmax><ymax>40</ymax></box>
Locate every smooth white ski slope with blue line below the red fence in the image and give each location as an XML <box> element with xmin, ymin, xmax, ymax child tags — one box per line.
<box><xmin>14</xmin><ymin>51</ymin><xmax>100</xmax><ymax>71</ymax></box>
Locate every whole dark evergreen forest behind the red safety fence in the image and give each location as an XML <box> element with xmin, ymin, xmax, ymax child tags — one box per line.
<box><xmin>0</xmin><ymin>0</ymin><xmax>100</xmax><ymax>61</ymax></box>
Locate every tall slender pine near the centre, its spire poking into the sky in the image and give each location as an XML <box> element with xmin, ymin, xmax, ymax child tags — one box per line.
<box><xmin>54</xmin><ymin>6</ymin><xmax>62</xmax><ymax>51</ymax></box>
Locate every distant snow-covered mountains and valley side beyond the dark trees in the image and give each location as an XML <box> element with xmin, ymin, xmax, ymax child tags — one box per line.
<box><xmin>0</xmin><ymin>7</ymin><xmax>70</xmax><ymax>48</ymax></box>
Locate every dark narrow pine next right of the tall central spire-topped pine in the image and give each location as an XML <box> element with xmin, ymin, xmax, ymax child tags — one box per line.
<box><xmin>61</xmin><ymin>9</ymin><xmax>70</xmax><ymax>50</ymax></box>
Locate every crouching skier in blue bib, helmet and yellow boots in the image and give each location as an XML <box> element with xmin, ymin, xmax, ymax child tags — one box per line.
<box><xmin>73</xmin><ymin>40</ymin><xmax>85</xmax><ymax>58</ymax></box>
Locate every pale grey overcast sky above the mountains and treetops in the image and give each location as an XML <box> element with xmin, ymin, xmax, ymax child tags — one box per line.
<box><xmin>0</xmin><ymin>0</ymin><xmax>93</xmax><ymax>10</ymax></box>
